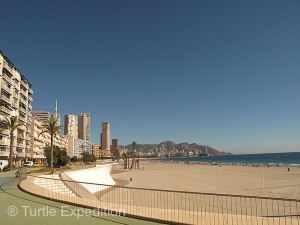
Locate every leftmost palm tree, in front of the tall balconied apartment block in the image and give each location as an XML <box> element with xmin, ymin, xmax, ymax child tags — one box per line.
<box><xmin>0</xmin><ymin>116</ymin><xmax>24</xmax><ymax>170</ymax></box>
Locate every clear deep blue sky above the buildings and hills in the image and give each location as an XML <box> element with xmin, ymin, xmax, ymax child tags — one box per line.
<box><xmin>0</xmin><ymin>0</ymin><xmax>300</xmax><ymax>153</ymax></box>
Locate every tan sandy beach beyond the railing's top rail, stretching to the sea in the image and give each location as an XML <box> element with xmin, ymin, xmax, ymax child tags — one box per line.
<box><xmin>111</xmin><ymin>160</ymin><xmax>300</xmax><ymax>199</ymax></box>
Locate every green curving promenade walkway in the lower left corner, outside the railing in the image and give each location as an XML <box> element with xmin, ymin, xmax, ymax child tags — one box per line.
<box><xmin>0</xmin><ymin>171</ymin><xmax>163</xmax><ymax>225</ymax></box>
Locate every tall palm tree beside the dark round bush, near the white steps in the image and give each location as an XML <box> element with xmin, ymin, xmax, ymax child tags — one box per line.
<box><xmin>39</xmin><ymin>114</ymin><xmax>62</xmax><ymax>173</ymax></box>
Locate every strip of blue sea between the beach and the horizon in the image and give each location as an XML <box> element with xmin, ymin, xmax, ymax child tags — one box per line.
<box><xmin>159</xmin><ymin>152</ymin><xmax>300</xmax><ymax>166</ymax></box>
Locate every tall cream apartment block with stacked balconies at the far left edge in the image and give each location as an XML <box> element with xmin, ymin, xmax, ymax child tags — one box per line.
<box><xmin>0</xmin><ymin>51</ymin><xmax>33</xmax><ymax>165</ymax></box>
